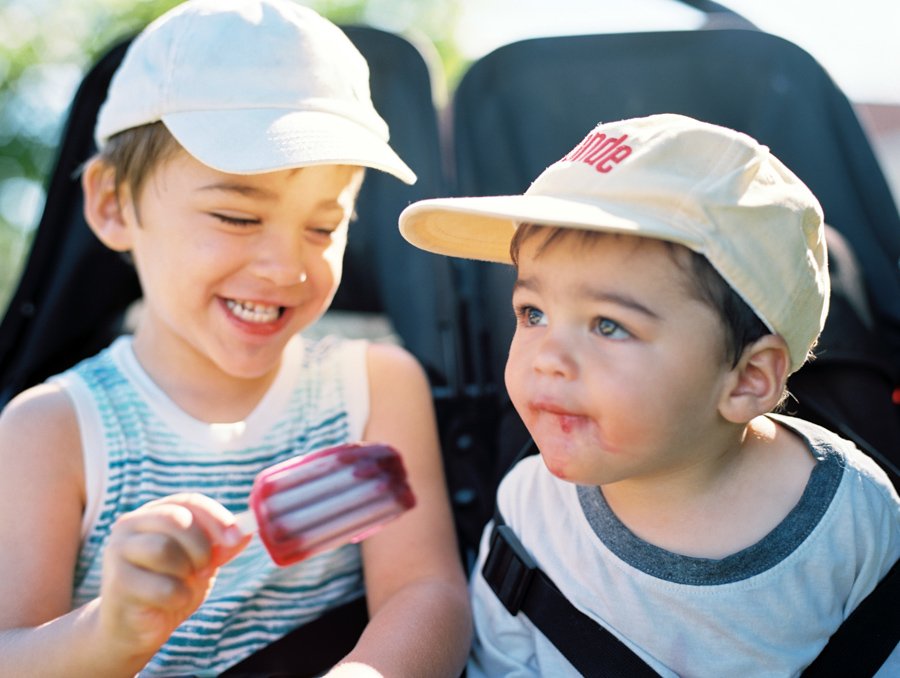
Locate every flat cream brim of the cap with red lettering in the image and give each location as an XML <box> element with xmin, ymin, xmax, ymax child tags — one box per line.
<box><xmin>400</xmin><ymin>194</ymin><xmax>702</xmax><ymax>264</ymax></box>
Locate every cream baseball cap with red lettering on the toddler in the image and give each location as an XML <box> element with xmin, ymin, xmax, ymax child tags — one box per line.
<box><xmin>400</xmin><ymin>114</ymin><xmax>830</xmax><ymax>372</ymax></box>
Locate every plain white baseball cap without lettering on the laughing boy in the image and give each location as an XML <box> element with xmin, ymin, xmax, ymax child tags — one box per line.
<box><xmin>94</xmin><ymin>0</ymin><xmax>416</xmax><ymax>184</ymax></box>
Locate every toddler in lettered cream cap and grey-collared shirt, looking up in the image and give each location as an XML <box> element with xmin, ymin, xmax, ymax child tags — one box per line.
<box><xmin>400</xmin><ymin>114</ymin><xmax>900</xmax><ymax>678</ymax></box>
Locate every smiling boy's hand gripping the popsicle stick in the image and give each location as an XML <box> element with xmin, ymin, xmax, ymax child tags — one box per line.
<box><xmin>100</xmin><ymin>494</ymin><xmax>249</xmax><ymax>654</ymax></box>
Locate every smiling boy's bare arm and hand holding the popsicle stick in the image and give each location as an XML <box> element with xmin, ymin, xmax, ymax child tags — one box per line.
<box><xmin>0</xmin><ymin>386</ymin><xmax>245</xmax><ymax>676</ymax></box>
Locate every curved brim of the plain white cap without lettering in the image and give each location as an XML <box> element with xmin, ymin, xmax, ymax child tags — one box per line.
<box><xmin>163</xmin><ymin>109</ymin><xmax>416</xmax><ymax>184</ymax></box>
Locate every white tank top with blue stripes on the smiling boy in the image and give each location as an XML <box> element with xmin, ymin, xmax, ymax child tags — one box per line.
<box><xmin>53</xmin><ymin>336</ymin><xmax>369</xmax><ymax>677</ymax></box>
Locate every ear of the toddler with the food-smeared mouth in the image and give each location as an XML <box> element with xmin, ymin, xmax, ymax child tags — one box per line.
<box><xmin>719</xmin><ymin>334</ymin><xmax>791</xmax><ymax>424</ymax></box>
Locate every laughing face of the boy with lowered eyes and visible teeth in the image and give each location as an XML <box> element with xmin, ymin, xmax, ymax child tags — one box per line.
<box><xmin>95</xmin><ymin>152</ymin><xmax>363</xmax><ymax>398</ymax></box>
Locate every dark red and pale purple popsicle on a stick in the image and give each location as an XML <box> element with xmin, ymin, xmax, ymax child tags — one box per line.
<box><xmin>238</xmin><ymin>443</ymin><xmax>416</xmax><ymax>566</ymax></box>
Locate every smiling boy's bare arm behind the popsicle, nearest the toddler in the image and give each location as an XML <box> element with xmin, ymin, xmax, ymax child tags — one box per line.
<box><xmin>347</xmin><ymin>346</ymin><xmax>472</xmax><ymax>676</ymax></box>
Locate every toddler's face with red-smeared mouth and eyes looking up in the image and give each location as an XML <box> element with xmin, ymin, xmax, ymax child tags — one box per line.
<box><xmin>506</xmin><ymin>230</ymin><xmax>734</xmax><ymax>485</ymax></box>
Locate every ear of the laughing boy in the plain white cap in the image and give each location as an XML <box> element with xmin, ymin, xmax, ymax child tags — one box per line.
<box><xmin>81</xmin><ymin>158</ymin><xmax>131</xmax><ymax>252</ymax></box>
